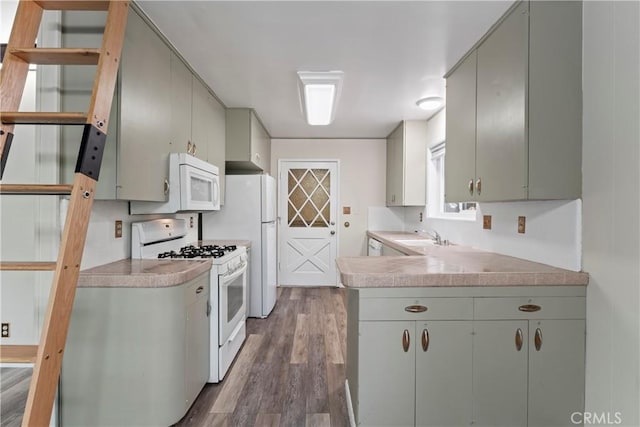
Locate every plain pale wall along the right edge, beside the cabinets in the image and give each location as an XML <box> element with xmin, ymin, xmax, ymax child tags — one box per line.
<box><xmin>582</xmin><ymin>1</ymin><xmax>640</xmax><ymax>426</ymax></box>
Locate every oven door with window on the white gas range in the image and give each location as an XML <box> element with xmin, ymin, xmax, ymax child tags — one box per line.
<box><xmin>218</xmin><ymin>261</ymin><xmax>247</xmax><ymax>345</ymax></box>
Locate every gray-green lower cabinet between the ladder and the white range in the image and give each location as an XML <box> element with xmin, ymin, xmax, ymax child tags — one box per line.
<box><xmin>60</xmin><ymin>272</ymin><xmax>209</xmax><ymax>427</ymax></box>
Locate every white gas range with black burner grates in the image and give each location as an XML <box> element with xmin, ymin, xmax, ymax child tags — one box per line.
<box><xmin>131</xmin><ymin>219</ymin><xmax>248</xmax><ymax>383</ymax></box>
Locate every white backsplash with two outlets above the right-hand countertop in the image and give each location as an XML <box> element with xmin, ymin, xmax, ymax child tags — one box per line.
<box><xmin>369</xmin><ymin>200</ymin><xmax>582</xmax><ymax>271</ymax></box>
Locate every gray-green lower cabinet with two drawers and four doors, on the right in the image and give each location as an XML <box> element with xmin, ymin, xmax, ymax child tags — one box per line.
<box><xmin>347</xmin><ymin>287</ymin><xmax>585</xmax><ymax>427</ymax></box>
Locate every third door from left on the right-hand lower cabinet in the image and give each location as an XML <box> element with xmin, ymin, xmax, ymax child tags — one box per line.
<box><xmin>473</xmin><ymin>320</ymin><xmax>529</xmax><ymax>427</ymax></box>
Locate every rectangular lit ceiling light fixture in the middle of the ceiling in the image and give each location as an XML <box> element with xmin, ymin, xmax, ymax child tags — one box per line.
<box><xmin>298</xmin><ymin>71</ymin><xmax>344</xmax><ymax>126</ymax></box>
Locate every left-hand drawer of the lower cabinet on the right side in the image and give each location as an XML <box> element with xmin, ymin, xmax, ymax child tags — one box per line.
<box><xmin>360</xmin><ymin>298</ymin><xmax>473</xmax><ymax>320</ymax></box>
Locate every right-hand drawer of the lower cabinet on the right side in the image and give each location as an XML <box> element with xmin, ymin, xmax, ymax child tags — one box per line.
<box><xmin>474</xmin><ymin>297</ymin><xmax>586</xmax><ymax>320</ymax></box>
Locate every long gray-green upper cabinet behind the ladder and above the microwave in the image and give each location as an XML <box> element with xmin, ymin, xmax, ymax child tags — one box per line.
<box><xmin>61</xmin><ymin>7</ymin><xmax>225</xmax><ymax>202</ymax></box>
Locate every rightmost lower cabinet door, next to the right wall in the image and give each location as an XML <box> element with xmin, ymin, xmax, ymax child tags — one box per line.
<box><xmin>528</xmin><ymin>320</ymin><xmax>585</xmax><ymax>427</ymax></box>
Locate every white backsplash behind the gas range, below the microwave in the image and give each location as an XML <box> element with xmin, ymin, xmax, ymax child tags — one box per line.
<box><xmin>66</xmin><ymin>200</ymin><xmax>198</xmax><ymax>270</ymax></box>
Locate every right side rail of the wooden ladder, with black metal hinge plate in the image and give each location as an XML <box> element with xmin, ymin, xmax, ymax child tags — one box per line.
<box><xmin>22</xmin><ymin>1</ymin><xmax>129</xmax><ymax>426</ymax></box>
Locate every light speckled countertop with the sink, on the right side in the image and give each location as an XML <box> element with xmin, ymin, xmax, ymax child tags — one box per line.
<box><xmin>337</xmin><ymin>231</ymin><xmax>589</xmax><ymax>288</ymax></box>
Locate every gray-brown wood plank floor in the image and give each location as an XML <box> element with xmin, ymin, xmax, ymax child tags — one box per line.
<box><xmin>0</xmin><ymin>288</ymin><xmax>349</xmax><ymax>427</ymax></box>
